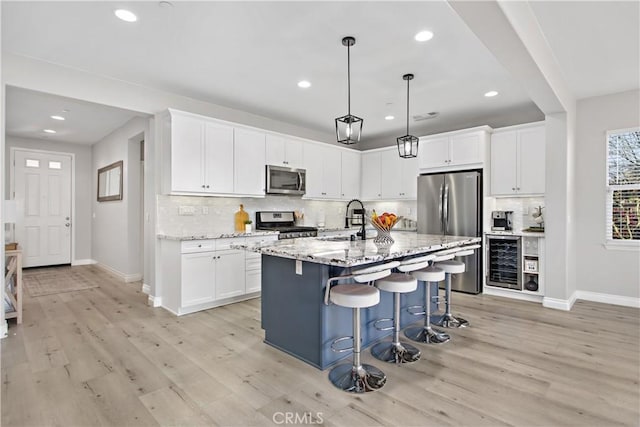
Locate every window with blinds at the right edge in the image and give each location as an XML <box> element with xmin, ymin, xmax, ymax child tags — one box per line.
<box><xmin>606</xmin><ymin>129</ymin><xmax>640</xmax><ymax>247</ymax></box>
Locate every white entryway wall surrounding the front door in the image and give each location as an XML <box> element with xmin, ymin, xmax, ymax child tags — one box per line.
<box><xmin>4</xmin><ymin>136</ymin><xmax>94</xmax><ymax>263</ymax></box>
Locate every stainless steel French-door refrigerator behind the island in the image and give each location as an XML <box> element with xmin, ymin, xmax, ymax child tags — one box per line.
<box><xmin>418</xmin><ymin>170</ymin><xmax>482</xmax><ymax>294</ymax></box>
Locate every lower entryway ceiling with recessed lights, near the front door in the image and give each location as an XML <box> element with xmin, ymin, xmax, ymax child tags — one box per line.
<box><xmin>5</xmin><ymin>86</ymin><xmax>143</xmax><ymax>145</ymax></box>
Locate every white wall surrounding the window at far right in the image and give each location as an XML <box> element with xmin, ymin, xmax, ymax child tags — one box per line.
<box><xmin>575</xmin><ymin>91</ymin><xmax>640</xmax><ymax>298</ymax></box>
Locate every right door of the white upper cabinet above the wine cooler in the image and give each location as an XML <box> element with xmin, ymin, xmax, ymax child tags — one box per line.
<box><xmin>517</xmin><ymin>127</ymin><xmax>545</xmax><ymax>194</ymax></box>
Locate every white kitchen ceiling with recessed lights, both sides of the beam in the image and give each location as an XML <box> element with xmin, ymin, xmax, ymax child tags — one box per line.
<box><xmin>2</xmin><ymin>1</ymin><xmax>638</xmax><ymax>149</ymax></box>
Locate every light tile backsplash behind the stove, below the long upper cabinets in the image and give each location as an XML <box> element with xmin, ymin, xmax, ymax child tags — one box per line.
<box><xmin>156</xmin><ymin>195</ymin><xmax>416</xmax><ymax>236</ymax></box>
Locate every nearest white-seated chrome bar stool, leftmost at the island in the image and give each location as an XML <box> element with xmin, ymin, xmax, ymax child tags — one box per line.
<box><xmin>324</xmin><ymin>261</ymin><xmax>400</xmax><ymax>393</ymax></box>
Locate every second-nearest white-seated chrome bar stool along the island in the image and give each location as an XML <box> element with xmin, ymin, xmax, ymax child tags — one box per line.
<box><xmin>371</xmin><ymin>255</ymin><xmax>433</xmax><ymax>364</ymax></box>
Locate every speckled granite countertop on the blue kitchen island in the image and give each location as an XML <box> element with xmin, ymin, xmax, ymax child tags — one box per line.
<box><xmin>231</xmin><ymin>232</ymin><xmax>481</xmax><ymax>267</ymax></box>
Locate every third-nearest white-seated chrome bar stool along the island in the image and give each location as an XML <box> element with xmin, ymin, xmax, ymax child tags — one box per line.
<box><xmin>404</xmin><ymin>250</ymin><xmax>454</xmax><ymax>344</ymax></box>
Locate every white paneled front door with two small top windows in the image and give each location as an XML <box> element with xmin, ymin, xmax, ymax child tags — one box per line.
<box><xmin>13</xmin><ymin>150</ymin><xmax>71</xmax><ymax>267</ymax></box>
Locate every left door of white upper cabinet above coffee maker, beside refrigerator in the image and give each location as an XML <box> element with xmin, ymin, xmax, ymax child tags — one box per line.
<box><xmin>491</xmin><ymin>131</ymin><xmax>517</xmax><ymax>195</ymax></box>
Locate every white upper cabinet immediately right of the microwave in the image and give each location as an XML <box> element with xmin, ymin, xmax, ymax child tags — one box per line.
<box><xmin>304</xmin><ymin>143</ymin><xmax>342</xmax><ymax>199</ymax></box>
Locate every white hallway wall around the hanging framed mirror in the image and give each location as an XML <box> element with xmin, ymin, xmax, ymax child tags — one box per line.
<box><xmin>91</xmin><ymin>117</ymin><xmax>148</xmax><ymax>280</ymax></box>
